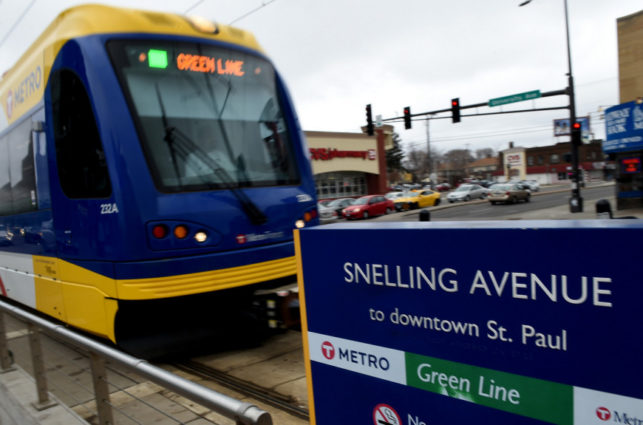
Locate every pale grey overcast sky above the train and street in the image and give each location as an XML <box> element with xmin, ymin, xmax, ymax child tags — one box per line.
<box><xmin>0</xmin><ymin>0</ymin><xmax>643</xmax><ymax>156</ymax></box>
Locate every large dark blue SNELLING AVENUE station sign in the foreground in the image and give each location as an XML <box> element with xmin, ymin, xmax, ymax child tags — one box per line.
<box><xmin>296</xmin><ymin>220</ymin><xmax>643</xmax><ymax>425</ymax></box>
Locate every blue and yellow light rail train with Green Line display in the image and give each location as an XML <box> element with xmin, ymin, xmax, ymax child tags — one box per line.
<box><xmin>0</xmin><ymin>5</ymin><xmax>318</xmax><ymax>352</ymax></box>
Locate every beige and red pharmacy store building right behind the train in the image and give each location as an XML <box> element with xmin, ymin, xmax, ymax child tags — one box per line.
<box><xmin>305</xmin><ymin>126</ymin><xmax>392</xmax><ymax>201</ymax></box>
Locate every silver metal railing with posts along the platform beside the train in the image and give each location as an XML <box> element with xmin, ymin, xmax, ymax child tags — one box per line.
<box><xmin>0</xmin><ymin>301</ymin><xmax>272</xmax><ymax>425</ymax></box>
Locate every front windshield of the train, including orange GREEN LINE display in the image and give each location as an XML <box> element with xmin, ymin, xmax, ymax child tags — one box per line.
<box><xmin>108</xmin><ymin>41</ymin><xmax>299</xmax><ymax>192</ymax></box>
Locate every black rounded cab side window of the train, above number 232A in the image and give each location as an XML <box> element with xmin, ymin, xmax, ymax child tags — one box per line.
<box><xmin>51</xmin><ymin>69</ymin><xmax>112</xmax><ymax>199</ymax></box>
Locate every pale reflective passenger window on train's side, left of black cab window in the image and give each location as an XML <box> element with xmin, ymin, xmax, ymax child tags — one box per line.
<box><xmin>8</xmin><ymin>119</ymin><xmax>37</xmax><ymax>214</ymax></box>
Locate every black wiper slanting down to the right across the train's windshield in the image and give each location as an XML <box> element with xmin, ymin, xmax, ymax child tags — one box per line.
<box><xmin>156</xmin><ymin>85</ymin><xmax>268</xmax><ymax>225</ymax></box>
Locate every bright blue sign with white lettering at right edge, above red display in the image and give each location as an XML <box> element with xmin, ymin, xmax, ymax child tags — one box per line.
<box><xmin>603</xmin><ymin>102</ymin><xmax>643</xmax><ymax>153</ymax></box>
